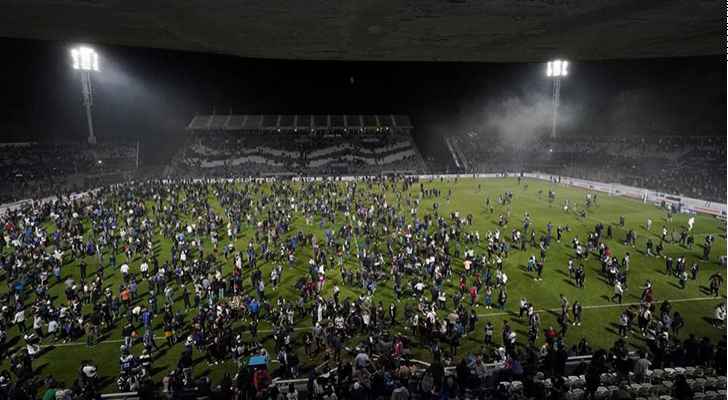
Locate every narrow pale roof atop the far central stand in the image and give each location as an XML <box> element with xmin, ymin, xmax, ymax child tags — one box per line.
<box><xmin>187</xmin><ymin>114</ymin><xmax>413</xmax><ymax>131</ymax></box>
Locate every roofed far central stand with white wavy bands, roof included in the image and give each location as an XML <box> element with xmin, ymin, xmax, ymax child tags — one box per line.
<box><xmin>172</xmin><ymin>114</ymin><xmax>425</xmax><ymax>176</ymax></box>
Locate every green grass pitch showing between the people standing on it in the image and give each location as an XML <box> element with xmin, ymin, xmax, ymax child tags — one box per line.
<box><xmin>0</xmin><ymin>178</ymin><xmax>726</xmax><ymax>391</ymax></box>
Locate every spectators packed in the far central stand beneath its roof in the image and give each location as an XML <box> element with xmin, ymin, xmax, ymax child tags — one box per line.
<box><xmin>171</xmin><ymin>131</ymin><xmax>425</xmax><ymax>177</ymax></box>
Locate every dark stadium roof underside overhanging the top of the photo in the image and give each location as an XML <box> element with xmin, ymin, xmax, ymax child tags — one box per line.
<box><xmin>0</xmin><ymin>0</ymin><xmax>725</xmax><ymax>62</ymax></box>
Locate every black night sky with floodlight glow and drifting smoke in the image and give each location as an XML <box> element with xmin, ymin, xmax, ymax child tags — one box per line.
<box><xmin>0</xmin><ymin>39</ymin><xmax>726</xmax><ymax>162</ymax></box>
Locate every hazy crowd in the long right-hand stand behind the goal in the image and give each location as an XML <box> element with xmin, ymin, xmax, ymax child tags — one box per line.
<box><xmin>451</xmin><ymin>135</ymin><xmax>726</xmax><ymax>202</ymax></box>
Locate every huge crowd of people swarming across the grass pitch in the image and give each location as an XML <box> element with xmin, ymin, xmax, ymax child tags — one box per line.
<box><xmin>0</xmin><ymin>173</ymin><xmax>725</xmax><ymax>399</ymax></box>
